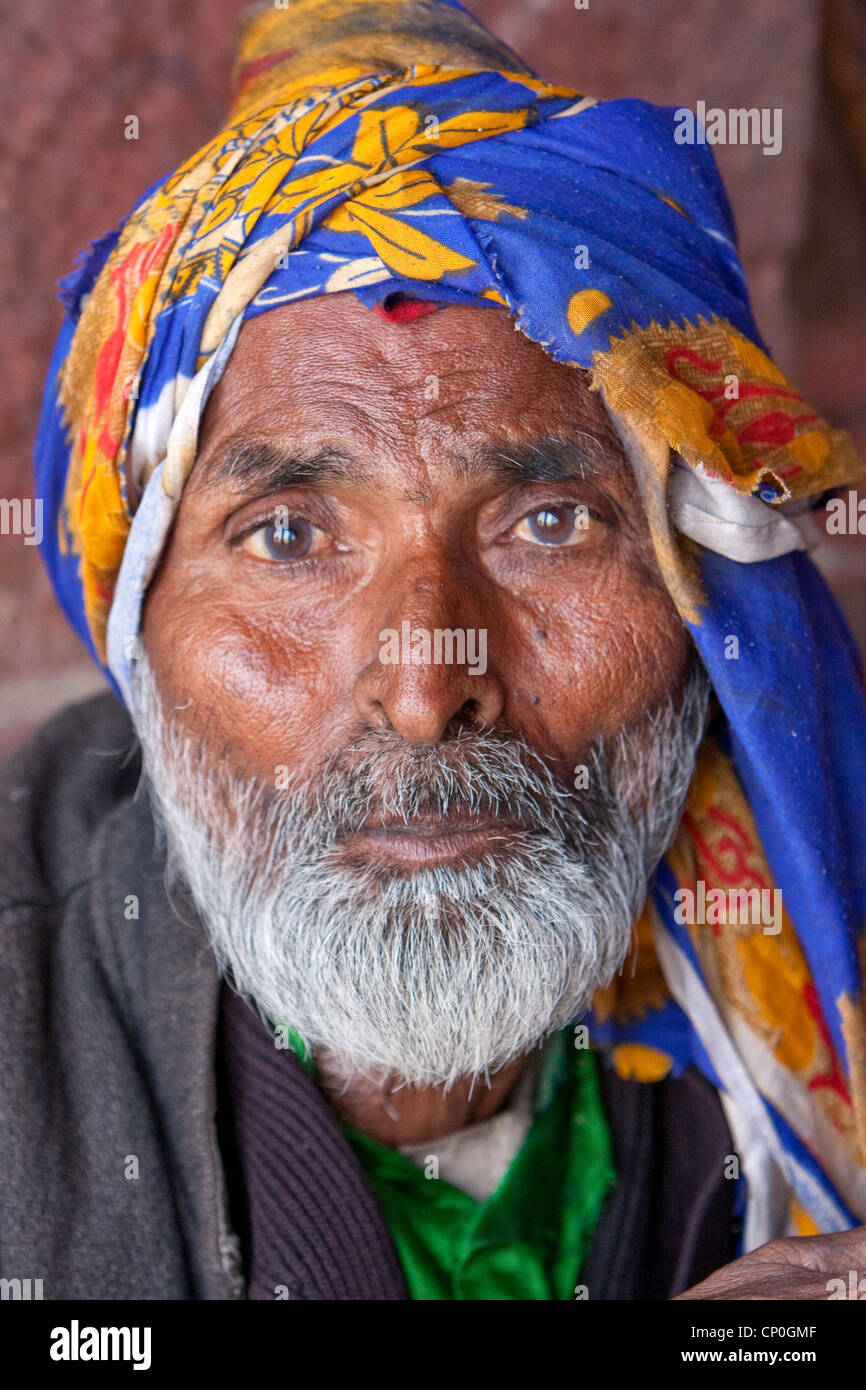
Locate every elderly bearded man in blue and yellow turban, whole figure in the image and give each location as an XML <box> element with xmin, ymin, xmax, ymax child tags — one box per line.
<box><xmin>0</xmin><ymin>0</ymin><xmax>866</xmax><ymax>1300</ymax></box>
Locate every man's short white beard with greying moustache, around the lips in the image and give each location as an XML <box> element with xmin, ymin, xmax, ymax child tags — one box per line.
<box><xmin>133</xmin><ymin>644</ymin><xmax>709</xmax><ymax>1087</ymax></box>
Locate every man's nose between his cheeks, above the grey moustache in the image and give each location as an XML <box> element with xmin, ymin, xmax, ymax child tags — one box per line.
<box><xmin>354</xmin><ymin>557</ymin><xmax>505</xmax><ymax>744</ymax></box>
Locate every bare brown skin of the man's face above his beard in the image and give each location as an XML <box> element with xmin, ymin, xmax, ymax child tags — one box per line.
<box><xmin>143</xmin><ymin>295</ymin><xmax>688</xmax><ymax>795</ymax></box>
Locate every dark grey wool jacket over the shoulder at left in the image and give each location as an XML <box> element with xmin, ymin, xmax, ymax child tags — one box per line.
<box><xmin>0</xmin><ymin>695</ymin><xmax>242</xmax><ymax>1298</ymax></box>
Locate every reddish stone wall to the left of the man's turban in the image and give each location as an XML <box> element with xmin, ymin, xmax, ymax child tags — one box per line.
<box><xmin>0</xmin><ymin>0</ymin><xmax>238</xmax><ymax>695</ymax></box>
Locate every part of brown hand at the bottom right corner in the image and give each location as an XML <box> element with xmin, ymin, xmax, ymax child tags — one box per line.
<box><xmin>673</xmin><ymin>1226</ymin><xmax>866</xmax><ymax>1302</ymax></box>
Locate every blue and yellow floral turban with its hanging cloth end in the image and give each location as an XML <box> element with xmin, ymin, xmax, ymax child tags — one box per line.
<box><xmin>36</xmin><ymin>0</ymin><xmax>866</xmax><ymax>1248</ymax></box>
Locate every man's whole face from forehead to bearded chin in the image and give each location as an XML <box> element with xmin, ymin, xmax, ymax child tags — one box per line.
<box><xmin>135</xmin><ymin>296</ymin><xmax>706</xmax><ymax>1086</ymax></box>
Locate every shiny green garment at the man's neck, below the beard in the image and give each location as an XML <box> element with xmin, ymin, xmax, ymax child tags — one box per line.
<box><xmin>278</xmin><ymin>1029</ymin><xmax>616</xmax><ymax>1300</ymax></box>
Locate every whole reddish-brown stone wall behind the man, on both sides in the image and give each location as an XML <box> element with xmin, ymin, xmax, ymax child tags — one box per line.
<box><xmin>0</xmin><ymin>0</ymin><xmax>866</xmax><ymax>749</ymax></box>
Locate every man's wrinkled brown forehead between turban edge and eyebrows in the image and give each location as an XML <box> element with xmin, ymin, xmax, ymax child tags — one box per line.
<box><xmin>190</xmin><ymin>295</ymin><xmax>627</xmax><ymax>484</ymax></box>
